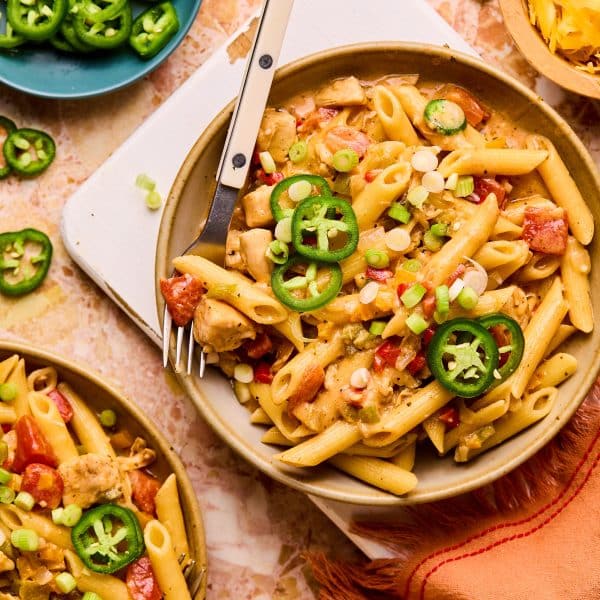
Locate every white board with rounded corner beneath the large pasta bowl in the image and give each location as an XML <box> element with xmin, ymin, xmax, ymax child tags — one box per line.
<box><xmin>61</xmin><ymin>0</ymin><xmax>475</xmax><ymax>558</ymax></box>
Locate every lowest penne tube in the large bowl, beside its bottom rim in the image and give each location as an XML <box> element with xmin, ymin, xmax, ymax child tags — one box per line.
<box><xmin>329</xmin><ymin>455</ymin><xmax>417</xmax><ymax>496</ymax></box>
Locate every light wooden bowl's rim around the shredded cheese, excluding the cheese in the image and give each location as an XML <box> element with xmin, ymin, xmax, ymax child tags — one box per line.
<box><xmin>500</xmin><ymin>0</ymin><xmax>600</xmax><ymax>99</ymax></box>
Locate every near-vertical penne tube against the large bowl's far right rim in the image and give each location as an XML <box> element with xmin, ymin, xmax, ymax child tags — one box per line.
<box><xmin>560</xmin><ymin>236</ymin><xmax>594</xmax><ymax>333</ymax></box>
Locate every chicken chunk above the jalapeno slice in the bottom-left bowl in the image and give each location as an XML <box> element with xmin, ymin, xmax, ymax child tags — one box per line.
<box><xmin>58</xmin><ymin>453</ymin><xmax>123</xmax><ymax>508</ymax></box>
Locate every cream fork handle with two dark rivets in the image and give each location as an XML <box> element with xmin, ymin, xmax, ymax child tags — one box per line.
<box><xmin>217</xmin><ymin>0</ymin><xmax>294</xmax><ymax>189</ymax></box>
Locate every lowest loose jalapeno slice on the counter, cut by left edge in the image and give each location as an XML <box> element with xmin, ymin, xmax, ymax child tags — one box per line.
<box><xmin>0</xmin><ymin>229</ymin><xmax>52</xmax><ymax>296</ymax></box>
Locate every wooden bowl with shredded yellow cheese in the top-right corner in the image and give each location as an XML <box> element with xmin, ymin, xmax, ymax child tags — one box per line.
<box><xmin>500</xmin><ymin>0</ymin><xmax>600</xmax><ymax>98</ymax></box>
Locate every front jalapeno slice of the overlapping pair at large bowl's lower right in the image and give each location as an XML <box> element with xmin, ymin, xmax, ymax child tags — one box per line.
<box><xmin>427</xmin><ymin>318</ymin><xmax>498</xmax><ymax>398</ymax></box>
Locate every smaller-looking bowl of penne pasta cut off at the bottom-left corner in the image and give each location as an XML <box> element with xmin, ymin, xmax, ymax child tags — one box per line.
<box><xmin>0</xmin><ymin>342</ymin><xmax>206</xmax><ymax>600</ymax></box>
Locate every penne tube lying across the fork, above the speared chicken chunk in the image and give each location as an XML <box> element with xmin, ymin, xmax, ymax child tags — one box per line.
<box><xmin>173</xmin><ymin>255</ymin><xmax>288</xmax><ymax>325</ymax></box>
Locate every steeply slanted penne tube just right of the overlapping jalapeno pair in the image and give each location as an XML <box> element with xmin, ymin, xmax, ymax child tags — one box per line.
<box><xmin>510</xmin><ymin>277</ymin><xmax>568</xmax><ymax>398</ymax></box>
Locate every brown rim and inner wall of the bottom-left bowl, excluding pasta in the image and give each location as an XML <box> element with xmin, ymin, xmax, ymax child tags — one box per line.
<box><xmin>0</xmin><ymin>341</ymin><xmax>207</xmax><ymax>600</ymax></box>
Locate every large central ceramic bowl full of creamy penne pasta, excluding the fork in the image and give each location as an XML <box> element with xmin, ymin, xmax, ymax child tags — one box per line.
<box><xmin>157</xmin><ymin>44</ymin><xmax>600</xmax><ymax>505</ymax></box>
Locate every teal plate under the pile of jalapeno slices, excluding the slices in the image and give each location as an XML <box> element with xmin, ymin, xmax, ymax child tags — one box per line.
<box><xmin>0</xmin><ymin>0</ymin><xmax>202</xmax><ymax>99</ymax></box>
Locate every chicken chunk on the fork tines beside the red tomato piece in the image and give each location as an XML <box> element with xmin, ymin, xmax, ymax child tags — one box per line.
<box><xmin>194</xmin><ymin>296</ymin><xmax>256</xmax><ymax>352</ymax></box>
